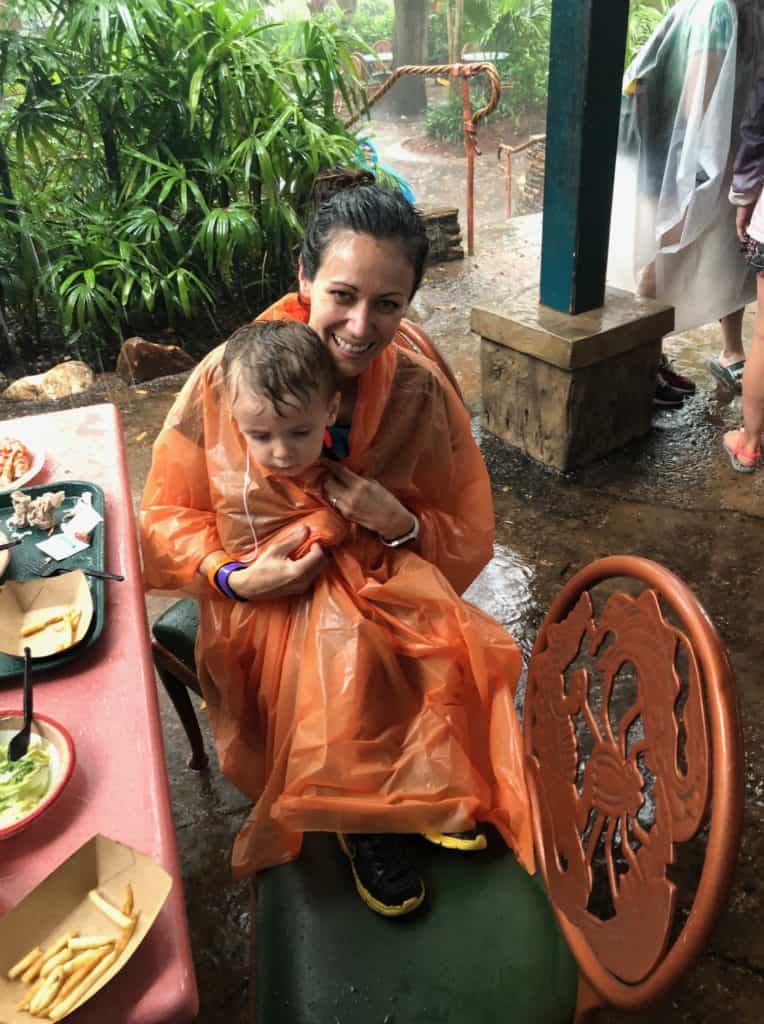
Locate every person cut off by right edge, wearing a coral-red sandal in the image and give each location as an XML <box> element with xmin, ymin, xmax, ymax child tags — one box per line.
<box><xmin>724</xmin><ymin>77</ymin><xmax>764</xmax><ymax>473</ymax></box>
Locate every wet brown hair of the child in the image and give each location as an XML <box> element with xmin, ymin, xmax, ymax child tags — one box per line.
<box><xmin>222</xmin><ymin>321</ymin><xmax>337</xmax><ymax>416</ymax></box>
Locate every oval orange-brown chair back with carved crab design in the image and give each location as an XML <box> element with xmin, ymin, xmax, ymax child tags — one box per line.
<box><xmin>523</xmin><ymin>556</ymin><xmax>744</xmax><ymax>1019</ymax></box>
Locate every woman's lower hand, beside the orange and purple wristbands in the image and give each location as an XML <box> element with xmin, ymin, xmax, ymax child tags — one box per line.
<box><xmin>223</xmin><ymin>526</ymin><xmax>327</xmax><ymax>601</ymax></box>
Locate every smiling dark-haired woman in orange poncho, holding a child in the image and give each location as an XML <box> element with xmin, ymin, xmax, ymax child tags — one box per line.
<box><xmin>141</xmin><ymin>173</ymin><xmax>533</xmax><ymax>915</ymax></box>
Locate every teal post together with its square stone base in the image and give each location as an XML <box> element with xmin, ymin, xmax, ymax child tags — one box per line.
<box><xmin>472</xmin><ymin>0</ymin><xmax>674</xmax><ymax>470</ymax></box>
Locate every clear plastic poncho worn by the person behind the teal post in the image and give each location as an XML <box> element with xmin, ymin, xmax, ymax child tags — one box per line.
<box><xmin>607</xmin><ymin>0</ymin><xmax>759</xmax><ymax>331</ymax></box>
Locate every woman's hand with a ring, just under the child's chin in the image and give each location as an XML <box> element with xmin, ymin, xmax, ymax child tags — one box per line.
<box><xmin>324</xmin><ymin>462</ymin><xmax>415</xmax><ymax>541</ymax></box>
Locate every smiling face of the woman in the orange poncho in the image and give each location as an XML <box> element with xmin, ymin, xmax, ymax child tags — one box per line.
<box><xmin>300</xmin><ymin>231</ymin><xmax>414</xmax><ymax>379</ymax></box>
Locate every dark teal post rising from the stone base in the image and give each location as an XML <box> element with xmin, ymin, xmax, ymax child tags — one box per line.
<box><xmin>541</xmin><ymin>0</ymin><xmax>629</xmax><ymax>313</ymax></box>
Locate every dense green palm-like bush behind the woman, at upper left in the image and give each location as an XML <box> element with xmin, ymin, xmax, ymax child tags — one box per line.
<box><xmin>0</xmin><ymin>0</ymin><xmax>366</xmax><ymax>364</ymax></box>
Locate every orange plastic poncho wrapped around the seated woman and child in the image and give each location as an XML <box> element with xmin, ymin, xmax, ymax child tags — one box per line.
<box><xmin>140</xmin><ymin>297</ymin><xmax>533</xmax><ymax>878</ymax></box>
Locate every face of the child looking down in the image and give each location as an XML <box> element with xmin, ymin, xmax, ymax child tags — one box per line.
<box><xmin>231</xmin><ymin>387</ymin><xmax>340</xmax><ymax>476</ymax></box>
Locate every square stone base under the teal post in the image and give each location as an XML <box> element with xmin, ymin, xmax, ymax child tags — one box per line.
<box><xmin>472</xmin><ymin>288</ymin><xmax>674</xmax><ymax>472</ymax></box>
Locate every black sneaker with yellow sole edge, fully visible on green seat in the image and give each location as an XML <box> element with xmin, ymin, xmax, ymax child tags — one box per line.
<box><xmin>337</xmin><ymin>833</ymin><xmax>424</xmax><ymax>918</ymax></box>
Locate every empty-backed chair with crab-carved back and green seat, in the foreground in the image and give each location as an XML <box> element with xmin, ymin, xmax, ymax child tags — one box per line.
<box><xmin>246</xmin><ymin>556</ymin><xmax>744</xmax><ymax>1024</ymax></box>
